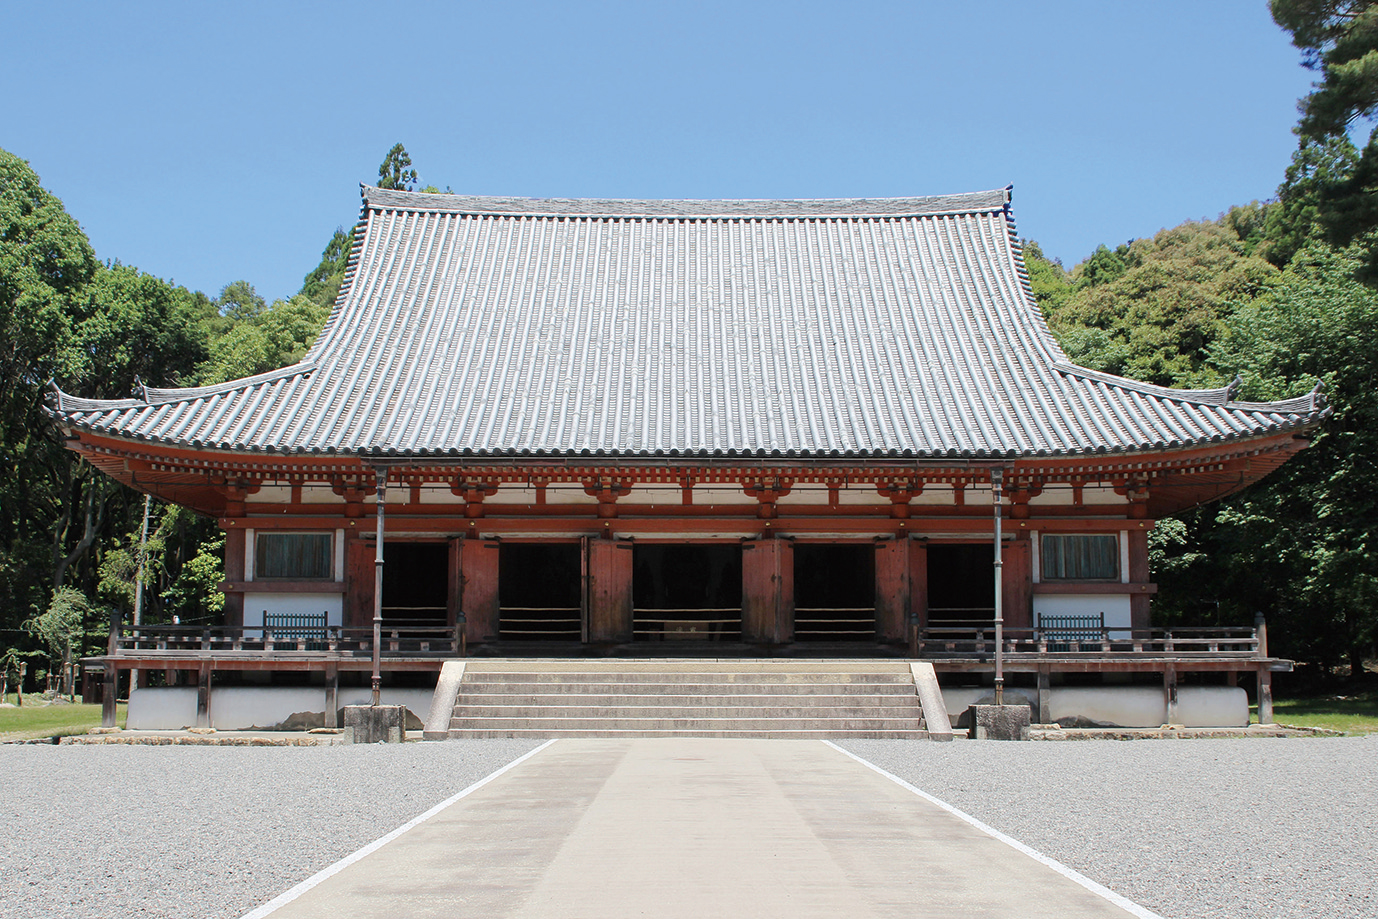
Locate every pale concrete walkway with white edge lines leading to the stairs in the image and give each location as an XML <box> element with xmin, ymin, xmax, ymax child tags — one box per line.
<box><xmin>253</xmin><ymin>739</ymin><xmax>1145</xmax><ymax>919</ymax></box>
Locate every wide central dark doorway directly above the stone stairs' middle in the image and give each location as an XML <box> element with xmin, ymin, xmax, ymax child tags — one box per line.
<box><xmin>631</xmin><ymin>543</ymin><xmax>741</xmax><ymax>641</ymax></box>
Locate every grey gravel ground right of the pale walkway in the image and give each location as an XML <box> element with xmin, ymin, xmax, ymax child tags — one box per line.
<box><xmin>841</xmin><ymin>734</ymin><xmax>1378</xmax><ymax>919</ymax></box>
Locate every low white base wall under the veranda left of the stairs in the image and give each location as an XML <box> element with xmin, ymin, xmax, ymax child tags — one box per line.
<box><xmin>125</xmin><ymin>686</ymin><xmax>433</xmax><ymax>730</ymax></box>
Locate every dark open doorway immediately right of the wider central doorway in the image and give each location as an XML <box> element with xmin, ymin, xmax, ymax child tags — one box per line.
<box><xmin>794</xmin><ymin>543</ymin><xmax>875</xmax><ymax>641</ymax></box>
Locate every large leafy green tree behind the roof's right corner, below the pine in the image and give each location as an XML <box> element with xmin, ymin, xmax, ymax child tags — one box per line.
<box><xmin>1159</xmin><ymin>242</ymin><xmax>1378</xmax><ymax>678</ymax></box>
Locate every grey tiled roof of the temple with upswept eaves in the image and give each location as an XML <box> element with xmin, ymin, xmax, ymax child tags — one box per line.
<box><xmin>54</xmin><ymin>186</ymin><xmax>1324</xmax><ymax>457</ymax></box>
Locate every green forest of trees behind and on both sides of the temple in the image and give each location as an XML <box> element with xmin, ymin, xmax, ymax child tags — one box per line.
<box><xmin>0</xmin><ymin>0</ymin><xmax>1378</xmax><ymax>685</ymax></box>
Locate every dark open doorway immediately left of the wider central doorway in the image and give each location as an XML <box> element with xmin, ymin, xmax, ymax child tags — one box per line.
<box><xmin>497</xmin><ymin>543</ymin><xmax>583</xmax><ymax>642</ymax></box>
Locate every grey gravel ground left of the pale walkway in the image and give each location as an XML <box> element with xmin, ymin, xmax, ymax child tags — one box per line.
<box><xmin>0</xmin><ymin>740</ymin><xmax>539</xmax><ymax>919</ymax></box>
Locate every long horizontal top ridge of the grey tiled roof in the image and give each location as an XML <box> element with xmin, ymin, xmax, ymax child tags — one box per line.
<box><xmin>360</xmin><ymin>183</ymin><xmax>1010</xmax><ymax>220</ymax></box>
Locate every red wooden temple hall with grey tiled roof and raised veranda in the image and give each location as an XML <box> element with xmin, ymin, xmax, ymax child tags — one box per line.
<box><xmin>51</xmin><ymin>186</ymin><xmax>1326</xmax><ymax>732</ymax></box>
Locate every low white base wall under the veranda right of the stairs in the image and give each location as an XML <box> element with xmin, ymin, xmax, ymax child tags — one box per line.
<box><xmin>943</xmin><ymin>686</ymin><xmax>1248</xmax><ymax>727</ymax></box>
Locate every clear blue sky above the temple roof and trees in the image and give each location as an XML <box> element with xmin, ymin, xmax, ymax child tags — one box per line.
<box><xmin>0</xmin><ymin>0</ymin><xmax>1312</xmax><ymax>299</ymax></box>
